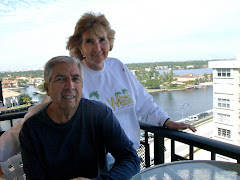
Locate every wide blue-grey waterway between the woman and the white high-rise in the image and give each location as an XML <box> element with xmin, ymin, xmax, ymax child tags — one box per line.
<box><xmin>153</xmin><ymin>86</ymin><xmax>213</xmax><ymax>121</ymax></box>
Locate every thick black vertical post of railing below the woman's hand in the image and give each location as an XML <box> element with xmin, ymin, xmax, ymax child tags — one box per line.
<box><xmin>154</xmin><ymin>134</ymin><xmax>164</xmax><ymax>165</ymax></box>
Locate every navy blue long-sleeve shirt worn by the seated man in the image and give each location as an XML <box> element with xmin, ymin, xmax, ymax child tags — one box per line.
<box><xmin>19</xmin><ymin>98</ymin><xmax>139</xmax><ymax>179</ymax></box>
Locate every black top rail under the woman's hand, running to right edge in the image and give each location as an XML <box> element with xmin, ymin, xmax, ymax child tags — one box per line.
<box><xmin>139</xmin><ymin>121</ymin><xmax>240</xmax><ymax>159</ymax></box>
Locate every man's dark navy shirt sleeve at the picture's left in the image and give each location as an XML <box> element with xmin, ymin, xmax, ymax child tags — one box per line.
<box><xmin>19</xmin><ymin>120</ymin><xmax>46</xmax><ymax>180</ymax></box>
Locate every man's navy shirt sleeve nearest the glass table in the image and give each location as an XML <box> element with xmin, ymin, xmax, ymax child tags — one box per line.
<box><xmin>96</xmin><ymin>108</ymin><xmax>140</xmax><ymax>179</ymax></box>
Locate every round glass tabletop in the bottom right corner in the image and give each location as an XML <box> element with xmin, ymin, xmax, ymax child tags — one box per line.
<box><xmin>132</xmin><ymin>160</ymin><xmax>240</xmax><ymax>180</ymax></box>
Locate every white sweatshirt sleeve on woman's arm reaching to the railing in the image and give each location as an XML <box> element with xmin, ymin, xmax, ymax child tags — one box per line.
<box><xmin>125</xmin><ymin>67</ymin><xmax>169</xmax><ymax>126</ymax></box>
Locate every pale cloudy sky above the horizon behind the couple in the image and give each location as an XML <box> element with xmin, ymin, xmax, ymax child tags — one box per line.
<box><xmin>0</xmin><ymin>0</ymin><xmax>240</xmax><ymax>72</ymax></box>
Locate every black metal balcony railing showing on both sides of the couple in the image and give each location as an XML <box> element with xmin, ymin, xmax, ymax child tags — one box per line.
<box><xmin>0</xmin><ymin>112</ymin><xmax>240</xmax><ymax>168</ymax></box>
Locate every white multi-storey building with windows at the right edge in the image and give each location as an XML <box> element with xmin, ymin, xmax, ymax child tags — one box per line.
<box><xmin>208</xmin><ymin>57</ymin><xmax>240</xmax><ymax>145</ymax></box>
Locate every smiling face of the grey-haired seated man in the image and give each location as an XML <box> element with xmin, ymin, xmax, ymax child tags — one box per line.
<box><xmin>44</xmin><ymin>63</ymin><xmax>83</xmax><ymax>111</ymax></box>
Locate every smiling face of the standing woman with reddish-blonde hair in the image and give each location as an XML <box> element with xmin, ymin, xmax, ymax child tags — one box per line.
<box><xmin>80</xmin><ymin>29</ymin><xmax>110</xmax><ymax>71</ymax></box>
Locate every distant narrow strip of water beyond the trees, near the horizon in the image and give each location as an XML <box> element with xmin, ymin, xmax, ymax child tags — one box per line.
<box><xmin>158</xmin><ymin>68</ymin><xmax>212</xmax><ymax>76</ymax></box>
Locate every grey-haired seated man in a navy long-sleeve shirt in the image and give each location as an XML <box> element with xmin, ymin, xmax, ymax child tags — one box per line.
<box><xmin>19</xmin><ymin>56</ymin><xmax>139</xmax><ymax>179</ymax></box>
